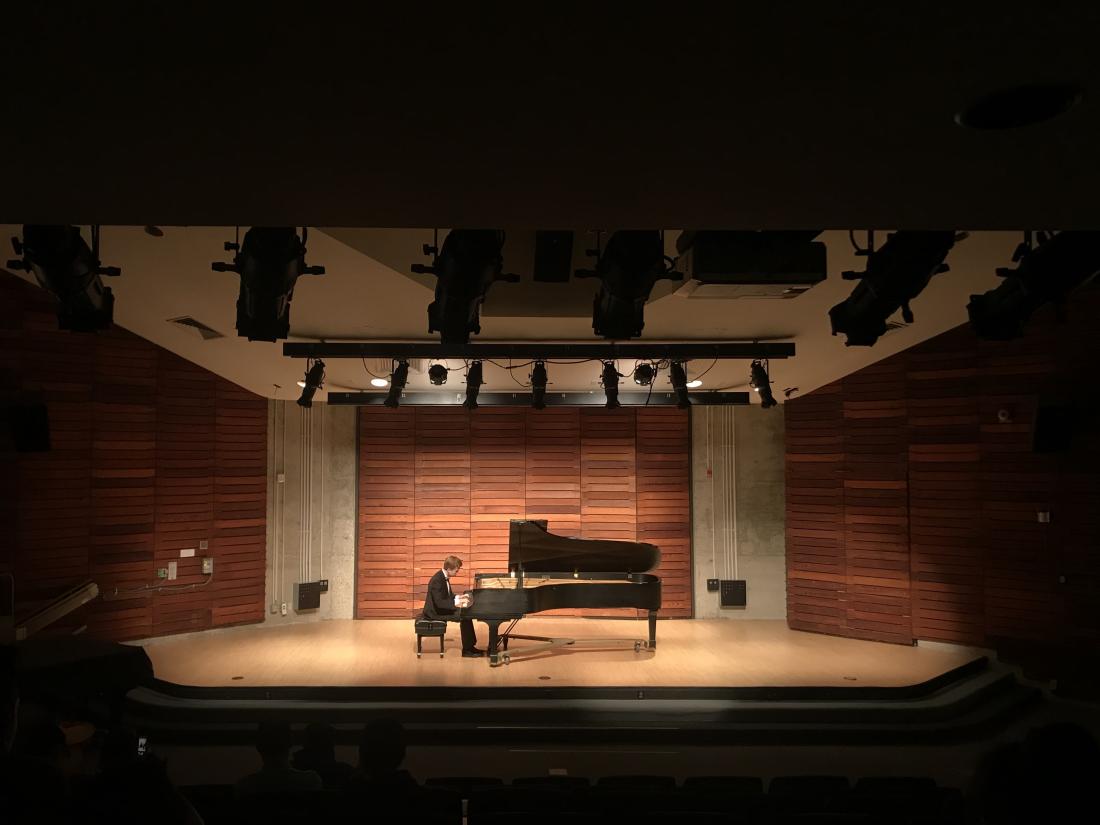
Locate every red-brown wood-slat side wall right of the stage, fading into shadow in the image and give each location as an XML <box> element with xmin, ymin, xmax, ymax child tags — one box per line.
<box><xmin>785</xmin><ymin>290</ymin><xmax>1100</xmax><ymax>650</ymax></box>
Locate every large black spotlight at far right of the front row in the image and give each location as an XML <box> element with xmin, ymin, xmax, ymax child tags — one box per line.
<box><xmin>967</xmin><ymin>232</ymin><xmax>1100</xmax><ymax>341</ymax></box>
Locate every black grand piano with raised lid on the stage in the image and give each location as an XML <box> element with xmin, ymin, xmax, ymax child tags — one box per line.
<box><xmin>454</xmin><ymin>519</ymin><xmax>661</xmax><ymax>666</ymax></box>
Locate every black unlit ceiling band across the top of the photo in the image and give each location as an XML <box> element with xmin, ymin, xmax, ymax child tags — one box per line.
<box><xmin>0</xmin><ymin>2</ymin><xmax>1100</xmax><ymax>229</ymax></box>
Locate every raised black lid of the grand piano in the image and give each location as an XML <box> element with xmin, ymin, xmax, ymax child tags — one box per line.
<box><xmin>508</xmin><ymin>518</ymin><xmax>661</xmax><ymax>573</ymax></box>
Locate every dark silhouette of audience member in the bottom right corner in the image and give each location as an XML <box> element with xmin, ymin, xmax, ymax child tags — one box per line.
<box><xmin>974</xmin><ymin>723</ymin><xmax>1100</xmax><ymax>825</ymax></box>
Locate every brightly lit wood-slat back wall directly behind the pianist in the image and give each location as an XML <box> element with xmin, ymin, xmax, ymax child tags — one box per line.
<box><xmin>355</xmin><ymin>407</ymin><xmax>691</xmax><ymax>618</ymax></box>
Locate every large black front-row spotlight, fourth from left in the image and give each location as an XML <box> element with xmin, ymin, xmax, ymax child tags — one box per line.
<box><xmin>575</xmin><ymin>230</ymin><xmax>683</xmax><ymax>340</ymax></box>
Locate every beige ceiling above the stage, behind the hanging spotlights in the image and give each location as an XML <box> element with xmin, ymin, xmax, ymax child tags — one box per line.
<box><xmin>0</xmin><ymin>226</ymin><xmax>1020</xmax><ymax>399</ymax></box>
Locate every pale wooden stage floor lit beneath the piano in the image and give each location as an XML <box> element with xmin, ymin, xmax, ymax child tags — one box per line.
<box><xmin>135</xmin><ymin>617</ymin><xmax>982</xmax><ymax>688</ymax></box>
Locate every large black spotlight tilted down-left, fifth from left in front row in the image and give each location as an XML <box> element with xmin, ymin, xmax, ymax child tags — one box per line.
<box><xmin>828</xmin><ymin>231</ymin><xmax>966</xmax><ymax>347</ymax></box>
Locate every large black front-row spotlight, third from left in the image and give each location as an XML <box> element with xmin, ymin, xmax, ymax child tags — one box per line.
<box><xmin>411</xmin><ymin>229</ymin><xmax>519</xmax><ymax>343</ymax></box>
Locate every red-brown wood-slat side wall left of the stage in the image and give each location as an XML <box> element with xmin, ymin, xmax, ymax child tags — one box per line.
<box><xmin>0</xmin><ymin>275</ymin><xmax>267</xmax><ymax>639</ymax></box>
